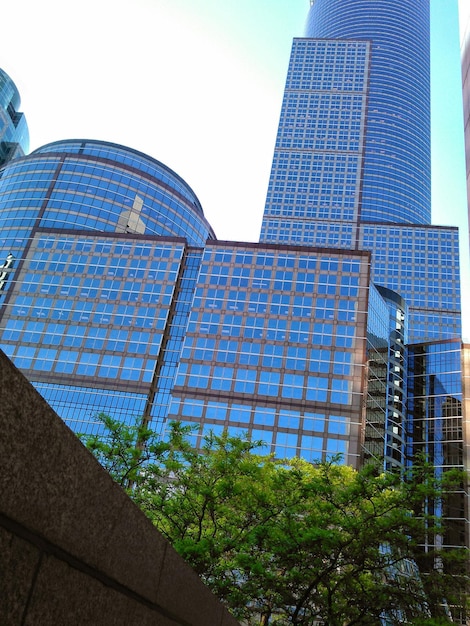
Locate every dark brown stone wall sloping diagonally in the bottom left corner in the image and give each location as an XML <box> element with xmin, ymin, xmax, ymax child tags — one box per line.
<box><xmin>0</xmin><ymin>352</ymin><xmax>241</xmax><ymax>626</ymax></box>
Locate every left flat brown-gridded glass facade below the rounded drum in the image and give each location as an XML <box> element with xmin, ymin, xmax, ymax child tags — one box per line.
<box><xmin>1</xmin><ymin>230</ymin><xmax>184</xmax><ymax>428</ymax></box>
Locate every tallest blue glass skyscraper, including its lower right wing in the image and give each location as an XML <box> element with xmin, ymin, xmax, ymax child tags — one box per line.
<box><xmin>261</xmin><ymin>0</ymin><xmax>461</xmax><ymax>342</ymax></box>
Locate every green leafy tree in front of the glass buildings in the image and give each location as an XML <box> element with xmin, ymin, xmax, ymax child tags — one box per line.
<box><xmin>83</xmin><ymin>416</ymin><xmax>465</xmax><ymax>626</ymax></box>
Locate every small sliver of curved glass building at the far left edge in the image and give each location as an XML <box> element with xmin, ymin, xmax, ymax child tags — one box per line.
<box><xmin>0</xmin><ymin>69</ymin><xmax>29</xmax><ymax>166</ymax></box>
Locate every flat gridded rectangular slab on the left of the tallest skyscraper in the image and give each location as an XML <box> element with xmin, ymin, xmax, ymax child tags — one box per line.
<box><xmin>260</xmin><ymin>39</ymin><xmax>370</xmax><ymax>248</ymax></box>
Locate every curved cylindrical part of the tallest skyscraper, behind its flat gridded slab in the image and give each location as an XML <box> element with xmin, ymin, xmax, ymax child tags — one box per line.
<box><xmin>306</xmin><ymin>0</ymin><xmax>431</xmax><ymax>224</ymax></box>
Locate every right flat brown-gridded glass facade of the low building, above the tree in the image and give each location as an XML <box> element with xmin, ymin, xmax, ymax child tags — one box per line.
<box><xmin>169</xmin><ymin>242</ymin><xmax>369</xmax><ymax>467</ymax></box>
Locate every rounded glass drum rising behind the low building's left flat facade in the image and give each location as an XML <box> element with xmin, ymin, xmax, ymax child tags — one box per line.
<box><xmin>0</xmin><ymin>140</ymin><xmax>214</xmax><ymax>251</ymax></box>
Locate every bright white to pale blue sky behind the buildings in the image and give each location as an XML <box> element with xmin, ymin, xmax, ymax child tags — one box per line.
<box><xmin>0</xmin><ymin>0</ymin><xmax>470</xmax><ymax>336</ymax></box>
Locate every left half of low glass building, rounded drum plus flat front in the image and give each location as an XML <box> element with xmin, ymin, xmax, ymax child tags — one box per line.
<box><xmin>0</xmin><ymin>140</ymin><xmax>214</xmax><ymax>430</ymax></box>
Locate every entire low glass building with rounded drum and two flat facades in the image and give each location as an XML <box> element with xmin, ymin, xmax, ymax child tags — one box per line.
<box><xmin>0</xmin><ymin>141</ymin><xmax>370</xmax><ymax>467</ymax></box>
